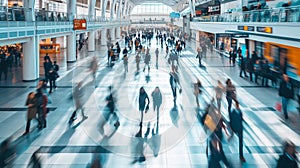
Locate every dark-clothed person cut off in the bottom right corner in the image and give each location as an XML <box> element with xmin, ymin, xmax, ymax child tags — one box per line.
<box><xmin>276</xmin><ymin>141</ymin><xmax>298</xmax><ymax>168</ymax></box>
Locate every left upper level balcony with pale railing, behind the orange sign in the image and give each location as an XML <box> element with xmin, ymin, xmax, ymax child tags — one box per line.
<box><xmin>0</xmin><ymin>7</ymin><xmax>130</xmax><ymax>40</ymax></box>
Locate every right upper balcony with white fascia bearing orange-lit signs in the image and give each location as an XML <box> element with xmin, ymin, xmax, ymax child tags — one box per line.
<box><xmin>175</xmin><ymin>6</ymin><xmax>300</xmax><ymax>47</ymax></box>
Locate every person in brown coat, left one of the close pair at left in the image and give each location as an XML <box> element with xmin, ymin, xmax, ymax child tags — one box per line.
<box><xmin>24</xmin><ymin>92</ymin><xmax>37</xmax><ymax>135</ymax></box>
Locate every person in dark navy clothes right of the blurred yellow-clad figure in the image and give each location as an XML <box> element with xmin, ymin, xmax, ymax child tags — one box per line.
<box><xmin>230</xmin><ymin>100</ymin><xmax>246</xmax><ymax>162</ymax></box>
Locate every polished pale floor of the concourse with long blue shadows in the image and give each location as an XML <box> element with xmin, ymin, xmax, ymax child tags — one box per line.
<box><xmin>0</xmin><ymin>38</ymin><xmax>300</xmax><ymax>168</ymax></box>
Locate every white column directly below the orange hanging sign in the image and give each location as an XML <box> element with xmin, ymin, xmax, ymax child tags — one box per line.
<box><xmin>67</xmin><ymin>32</ymin><xmax>77</xmax><ymax>63</ymax></box>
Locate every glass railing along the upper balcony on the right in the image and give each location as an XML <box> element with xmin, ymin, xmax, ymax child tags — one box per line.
<box><xmin>192</xmin><ymin>6</ymin><xmax>300</xmax><ymax>22</ymax></box>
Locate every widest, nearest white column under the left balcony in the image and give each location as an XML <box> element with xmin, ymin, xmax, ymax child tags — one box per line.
<box><xmin>23</xmin><ymin>37</ymin><xmax>39</xmax><ymax>82</ymax></box>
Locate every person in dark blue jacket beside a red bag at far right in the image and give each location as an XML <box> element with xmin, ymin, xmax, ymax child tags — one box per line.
<box><xmin>279</xmin><ymin>74</ymin><xmax>294</xmax><ymax>119</ymax></box>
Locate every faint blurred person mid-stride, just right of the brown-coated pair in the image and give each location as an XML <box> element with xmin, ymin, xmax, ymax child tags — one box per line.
<box><xmin>69</xmin><ymin>82</ymin><xmax>88</xmax><ymax>124</ymax></box>
